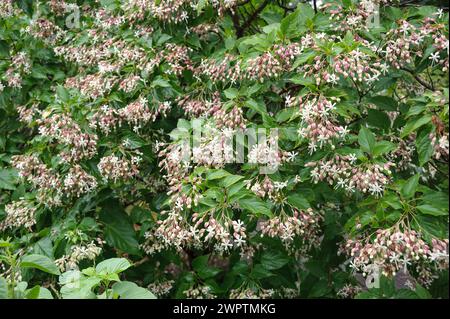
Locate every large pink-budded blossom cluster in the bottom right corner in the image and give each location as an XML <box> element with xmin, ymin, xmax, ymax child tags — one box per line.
<box><xmin>343</xmin><ymin>228</ymin><xmax>448</xmax><ymax>286</ymax></box>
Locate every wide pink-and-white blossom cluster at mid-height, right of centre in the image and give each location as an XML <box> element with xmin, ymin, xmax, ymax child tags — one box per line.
<box><xmin>306</xmin><ymin>155</ymin><xmax>393</xmax><ymax>196</ymax></box>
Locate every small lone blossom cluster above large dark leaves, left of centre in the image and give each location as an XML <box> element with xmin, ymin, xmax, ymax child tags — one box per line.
<box><xmin>97</xmin><ymin>155</ymin><xmax>140</xmax><ymax>183</ymax></box>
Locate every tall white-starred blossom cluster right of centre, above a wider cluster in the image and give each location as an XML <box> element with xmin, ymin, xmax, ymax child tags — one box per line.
<box><xmin>292</xmin><ymin>96</ymin><xmax>348</xmax><ymax>154</ymax></box>
